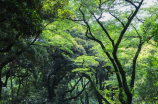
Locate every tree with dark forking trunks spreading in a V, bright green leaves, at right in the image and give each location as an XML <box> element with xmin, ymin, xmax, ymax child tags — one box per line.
<box><xmin>73</xmin><ymin>0</ymin><xmax>155</xmax><ymax>104</ymax></box>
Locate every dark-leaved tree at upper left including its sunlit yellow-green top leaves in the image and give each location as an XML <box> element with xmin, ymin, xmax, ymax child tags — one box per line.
<box><xmin>0</xmin><ymin>0</ymin><xmax>70</xmax><ymax>101</ymax></box>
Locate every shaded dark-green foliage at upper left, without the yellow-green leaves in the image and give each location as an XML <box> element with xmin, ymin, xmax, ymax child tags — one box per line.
<box><xmin>0</xmin><ymin>0</ymin><xmax>41</xmax><ymax>98</ymax></box>
